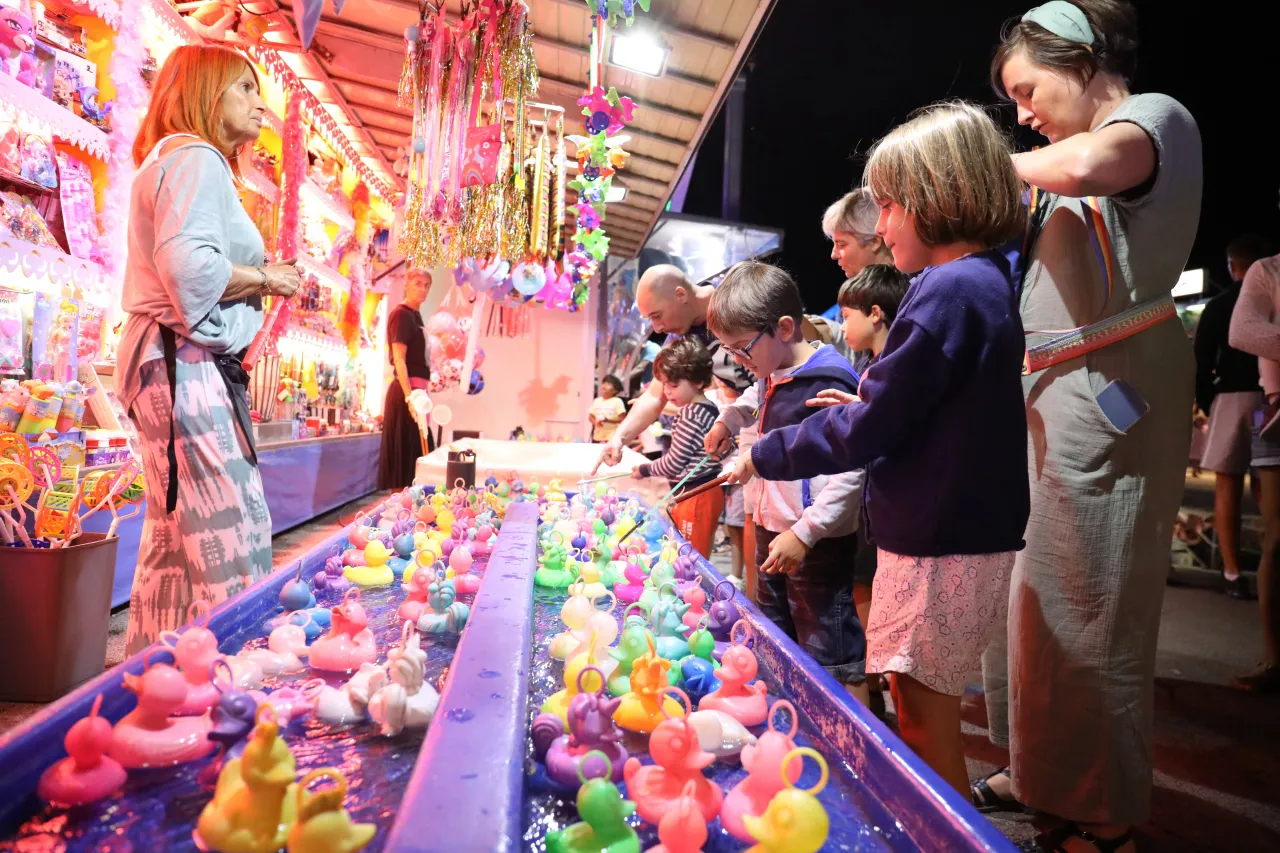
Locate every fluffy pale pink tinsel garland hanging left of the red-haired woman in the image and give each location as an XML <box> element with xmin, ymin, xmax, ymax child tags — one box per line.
<box><xmin>99</xmin><ymin>0</ymin><xmax>148</xmax><ymax>297</ymax></box>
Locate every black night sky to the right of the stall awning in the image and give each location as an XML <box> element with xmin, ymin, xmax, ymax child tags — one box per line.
<box><xmin>685</xmin><ymin>0</ymin><xmax>1280</xmax><ymax>313</ymax></box>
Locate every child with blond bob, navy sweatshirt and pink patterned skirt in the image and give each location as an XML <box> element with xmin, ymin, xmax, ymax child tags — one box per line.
<box><xmin>735</xmin><ymin>104</ymin><xmax>1030</xmax><ymax>797</ymax></box>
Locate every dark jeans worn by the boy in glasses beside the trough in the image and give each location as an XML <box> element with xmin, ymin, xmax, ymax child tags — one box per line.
<box><xmin>755</xmin><ymin>526</ymin><xmax>867</xmax><ymax>684</ymax></box>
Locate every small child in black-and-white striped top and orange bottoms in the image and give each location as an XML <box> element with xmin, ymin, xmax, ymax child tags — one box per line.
<box><xmin>635</xmin><ymin>336</ymin><xmax>724</xmax><ymax>560</ymax></box>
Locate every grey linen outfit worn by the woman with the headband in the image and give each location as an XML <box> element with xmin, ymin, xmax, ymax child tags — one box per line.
<box><xmin>983</xmin><ymin>93</ymin><xmax>1202</xmax><ymax>825</ymax></box>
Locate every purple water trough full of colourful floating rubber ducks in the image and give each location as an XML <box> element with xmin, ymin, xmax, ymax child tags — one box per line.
<box><xmin>0</xmin><ymin>471</ymin><xmax>1011</xmax><ymax>853</ymax></box>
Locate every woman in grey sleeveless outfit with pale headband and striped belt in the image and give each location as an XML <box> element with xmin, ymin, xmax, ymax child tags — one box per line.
<box><xmin>974</xmin><ymin>0</ymin><xmax>1202</xmax><ymax>853</ymax></box>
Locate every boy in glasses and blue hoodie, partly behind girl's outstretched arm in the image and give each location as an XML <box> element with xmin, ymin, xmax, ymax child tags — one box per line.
<box><xmin>707</xmin><ymin>261</ymin><xmax>868</xmax><ymax>703</ymax></box>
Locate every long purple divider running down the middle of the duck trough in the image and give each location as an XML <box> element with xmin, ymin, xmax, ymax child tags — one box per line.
<box><xmin>385</xmin><ymin>503</ymin><xmax>538</xmax><ymax>853</ymax></box>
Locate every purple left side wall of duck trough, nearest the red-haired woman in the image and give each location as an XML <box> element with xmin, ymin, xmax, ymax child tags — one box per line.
<box><xmin>0</xmin><ymin>517</ymin><xmax>349</xmax><ymax>834</ymax></box>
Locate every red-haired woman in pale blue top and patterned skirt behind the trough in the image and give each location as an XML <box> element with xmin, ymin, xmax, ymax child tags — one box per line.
<box><xmin>115</xmin><ymin>46</ymin><xmax>298</xmax><ymax>654</ymax></box>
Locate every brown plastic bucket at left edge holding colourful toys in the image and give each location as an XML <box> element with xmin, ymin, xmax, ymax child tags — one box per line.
<box><xmin>0</xmin><ymin>533</ymin><xmax>120</xmax><ymax>702</ymax></box>
